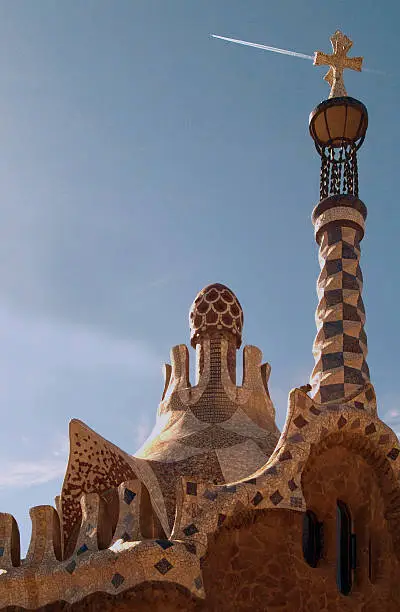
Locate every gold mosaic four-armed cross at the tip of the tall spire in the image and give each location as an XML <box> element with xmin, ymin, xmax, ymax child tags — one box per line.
<box><xmin>314</xmin><ymin>30</ymin><xmax>363</xmax><ymax>98</ymax></box>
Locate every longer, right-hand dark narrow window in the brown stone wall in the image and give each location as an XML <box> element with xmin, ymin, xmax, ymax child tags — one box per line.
<box><xmin>336</xmin><ymin>500</ymin><xmax>356</xmax><ymax>595</ymax></box>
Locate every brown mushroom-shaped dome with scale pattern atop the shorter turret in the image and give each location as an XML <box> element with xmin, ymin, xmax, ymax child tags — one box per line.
<box><xmin>189</xmin><ymin>283</ymin><xmax>243</xmax><ymax>348</ymax></box>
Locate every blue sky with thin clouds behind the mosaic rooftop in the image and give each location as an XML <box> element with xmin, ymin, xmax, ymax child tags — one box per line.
<box><xmin>0</xmin><ymin>0</ymin><xmax>400</xmax><ymax>549</ymax></box>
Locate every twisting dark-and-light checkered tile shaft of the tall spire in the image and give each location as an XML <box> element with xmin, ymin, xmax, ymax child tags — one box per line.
<box><xmin>311</xmin><ymin>222</ymin><xmax>369</xmax><ymax>403</ymax></box>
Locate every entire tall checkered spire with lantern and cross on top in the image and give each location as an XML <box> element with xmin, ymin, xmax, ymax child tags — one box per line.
<box><xmin>310</xmin><ymin>31</ymin><xmax>372</xmax><ymax>412</ymax></box>
